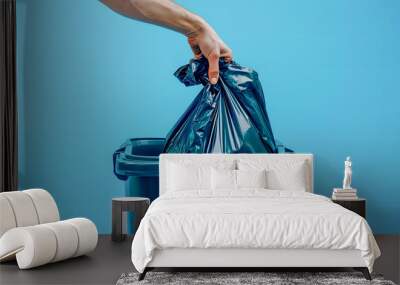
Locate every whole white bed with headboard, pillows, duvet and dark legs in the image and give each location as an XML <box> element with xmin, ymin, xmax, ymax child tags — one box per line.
<box><xmin>132</xmin><ymin>154</ymin><xmax>380</xmax><ymax>278</ymax></box>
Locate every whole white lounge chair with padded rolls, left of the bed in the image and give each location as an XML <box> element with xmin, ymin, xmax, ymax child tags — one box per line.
<box><xmin>0</xmin><ymin>189</ymin><xmax>98</xmax><ymax>269</ymax></box>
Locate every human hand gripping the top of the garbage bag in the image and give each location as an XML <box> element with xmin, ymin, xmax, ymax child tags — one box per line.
<box><xmin>187</xmin><ymin>24</ymin><xmax>232</xmax><ymax>84</ymax></box>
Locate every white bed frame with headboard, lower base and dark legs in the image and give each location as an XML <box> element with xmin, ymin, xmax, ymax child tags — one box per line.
<box><xmin>139</xmin><ymin>154</ymin><xmax>371</xmax><ymax>280</ymax></box>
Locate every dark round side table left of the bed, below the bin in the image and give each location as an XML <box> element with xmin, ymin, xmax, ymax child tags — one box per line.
<box><xmin>111</xmin><ymin>197</ymin><xmax>150</xmax><ymax>241</ymax></box>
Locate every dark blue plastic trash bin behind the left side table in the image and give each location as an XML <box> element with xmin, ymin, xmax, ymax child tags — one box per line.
<box><xmin>113</xmin><ymin>138</ymin><xmax>165</xmax><ymax>234</ymax></box>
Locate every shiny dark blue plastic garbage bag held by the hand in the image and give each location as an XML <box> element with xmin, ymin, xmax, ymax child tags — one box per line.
<box><xmin>164</xmin><ymin>57</ymin><xmax>290</xmax><ymax>153</ymax></box>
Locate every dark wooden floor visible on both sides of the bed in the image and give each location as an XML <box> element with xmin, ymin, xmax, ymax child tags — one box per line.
<box><xmin>0</xmin><ymin>235</ymin><xmax>400</xmax><ymax>285</ymax></box>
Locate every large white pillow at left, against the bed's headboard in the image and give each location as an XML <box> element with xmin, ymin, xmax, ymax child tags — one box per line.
<box><xmin>166</xmin><ymin>160</ymin><xmax>236</xmax><ymax>191</ymax></box>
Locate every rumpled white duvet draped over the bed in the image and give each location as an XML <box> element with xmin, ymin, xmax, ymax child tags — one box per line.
<box><xmin>132</xmin><ymin>189</ymin><xmax>380</xmax><ymax>272</ymax></box>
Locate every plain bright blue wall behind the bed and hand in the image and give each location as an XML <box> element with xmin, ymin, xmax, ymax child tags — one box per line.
<box><xmin>17</xmin><ymin>0</ymin><xmax>400</xmax><ymax>233</ymax></box>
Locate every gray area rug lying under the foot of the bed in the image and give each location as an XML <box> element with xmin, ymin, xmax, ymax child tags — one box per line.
<box><xmin>117</xmin><ymin>272</ymin><xmax>395</xmax><ymax>285</ymax></box>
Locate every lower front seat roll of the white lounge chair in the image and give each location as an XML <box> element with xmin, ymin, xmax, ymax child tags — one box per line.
<box><xmin>0</xmin><ymin>218</ymin><xmax>97</xmax><ymax>269</ymax></box>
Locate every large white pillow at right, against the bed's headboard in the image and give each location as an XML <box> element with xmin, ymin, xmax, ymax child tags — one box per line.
<box><xmin>238</xmin><ymin>159</ymin><xmax>309</xmax><ymax>191</ymax></box>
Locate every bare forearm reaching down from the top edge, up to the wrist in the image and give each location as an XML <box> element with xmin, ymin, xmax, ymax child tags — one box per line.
<box><xmin>101</xmin><ymin>0</ymin><xmax>207</xmax><ymax>36</ymax></box>
